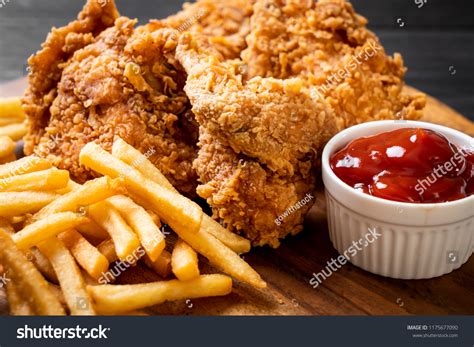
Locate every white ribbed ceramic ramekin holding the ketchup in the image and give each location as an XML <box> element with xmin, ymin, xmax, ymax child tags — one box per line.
<box><xmin>322</xmin><ymin>121</ymin><xmax>474</xmax><ymax>279</ymax></box>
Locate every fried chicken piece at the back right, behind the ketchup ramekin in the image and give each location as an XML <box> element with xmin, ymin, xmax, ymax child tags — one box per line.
<box><xmin>242</xmin><ymin>0</ymin><xmax>426</xmax><ymax>127</ymax></box>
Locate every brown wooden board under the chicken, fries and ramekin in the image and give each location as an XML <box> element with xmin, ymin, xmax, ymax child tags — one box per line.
<box><xmin>0</xmin><ymin>80</ymin><xmax>474</xmax><ymax>315</ymax></box>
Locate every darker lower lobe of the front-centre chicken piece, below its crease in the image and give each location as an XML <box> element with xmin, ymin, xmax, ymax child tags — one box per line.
<box><xmin>194</xmin><ymin>128</ymin><xmax>316</xmax><ymax>247</ymax></box>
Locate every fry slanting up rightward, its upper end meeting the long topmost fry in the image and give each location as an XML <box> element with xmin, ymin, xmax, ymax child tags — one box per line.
<box><xmin>33</xmin><ymin>177</ymin><xmax>123</xmax><ymax>220</ymax></box>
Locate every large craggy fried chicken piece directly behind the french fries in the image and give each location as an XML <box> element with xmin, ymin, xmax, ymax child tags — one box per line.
<box><xmin>22</xmin><ymin>1</ymin><xmax>197</xmax><ymax>196</ymax></box>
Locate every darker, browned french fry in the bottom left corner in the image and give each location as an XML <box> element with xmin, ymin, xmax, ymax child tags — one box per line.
<box><xmin>0</xmin><ymin>229</ymin><xmax>65</xmax><ymax>316</ymax></box>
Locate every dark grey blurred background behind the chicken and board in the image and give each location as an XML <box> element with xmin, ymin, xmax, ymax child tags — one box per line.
<box><xmin>0</xmin><ymin>0</ymin><xmax>474</xmax><ymax>120</ymax></box>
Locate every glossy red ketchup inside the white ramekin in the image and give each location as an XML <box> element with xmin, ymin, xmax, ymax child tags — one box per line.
<box><xmin>330</xmin><ymin>128</ymin><xmax>474</xmax><ymax>203</ymax></box>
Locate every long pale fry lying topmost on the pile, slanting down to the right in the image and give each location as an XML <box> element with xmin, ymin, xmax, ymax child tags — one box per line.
<box><xmin>79</xmin><ymin>142</ymin><xmax>203</xmax><ymax>232</ymax></box>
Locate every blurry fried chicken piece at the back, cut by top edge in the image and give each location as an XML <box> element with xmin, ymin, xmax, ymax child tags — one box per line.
<box><xmin>163</xmin><ymin>0</ymin><xmax>254</xmax><ymax>59</ymax></box>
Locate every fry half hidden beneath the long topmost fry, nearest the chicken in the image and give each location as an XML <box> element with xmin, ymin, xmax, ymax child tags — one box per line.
<box><xmin>112</xmin><ymin>139</ymin><xmax>251</xmax><ymax>254</ymax></box>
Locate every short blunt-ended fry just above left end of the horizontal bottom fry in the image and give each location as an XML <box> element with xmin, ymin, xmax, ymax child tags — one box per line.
<box><xmin>58</xmin><ymin>229</ymin><xmax>109</xmax><ymax>279</ymax></box>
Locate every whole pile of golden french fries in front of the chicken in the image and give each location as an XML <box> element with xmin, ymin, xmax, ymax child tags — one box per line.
<box><xmin>0</xmin><ymin>97</ymin><xmax>266</xmax><ymax>315</ymax></box>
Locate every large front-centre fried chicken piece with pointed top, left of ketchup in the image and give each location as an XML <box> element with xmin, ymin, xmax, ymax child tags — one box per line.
<box><xmin>176</xmin><ymin>33</ymin><xmax>338</xmax><ymax>247</ymax></box>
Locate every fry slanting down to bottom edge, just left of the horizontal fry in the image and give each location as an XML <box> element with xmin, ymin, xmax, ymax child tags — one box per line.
<box><xmin>38</xmin><ymin>237</ymin><xmax>95</xmax><ymax>316</ymax></box>
